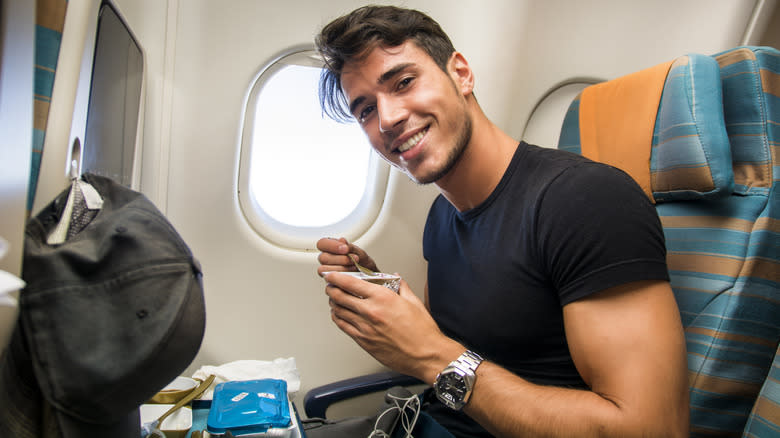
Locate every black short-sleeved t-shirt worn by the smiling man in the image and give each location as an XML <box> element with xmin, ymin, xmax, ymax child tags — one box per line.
<box><xmin>423</xmin><ymin>142</ymin><xmax>668</xmax><ymax>436</ymax></box>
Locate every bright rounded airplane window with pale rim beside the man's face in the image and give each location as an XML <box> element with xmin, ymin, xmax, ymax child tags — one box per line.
<box><xmin>239</xmin><ymin>50</ymin><xmax>388</xmax><ymax>249</ymax></box>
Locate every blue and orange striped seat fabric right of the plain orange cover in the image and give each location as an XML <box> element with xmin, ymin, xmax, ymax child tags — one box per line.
<box><xmin>558</xmin><ymin>47</ymin><xmax>780</xmax><ymax>437</ymax></box>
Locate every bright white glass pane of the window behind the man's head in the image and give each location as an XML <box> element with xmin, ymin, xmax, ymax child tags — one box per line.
<box><xmin>249</xmin><ymin>61</ymin><xmax>370</xmax><ymax>226</ymax></box>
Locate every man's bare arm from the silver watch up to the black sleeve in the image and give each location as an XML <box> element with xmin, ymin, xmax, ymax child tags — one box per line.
<box><xmin>465</xmin><ymin>282</ymin><xmax>689</xmax><ymax>437</ymax></box>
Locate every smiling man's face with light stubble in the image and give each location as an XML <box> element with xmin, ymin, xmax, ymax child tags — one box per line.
<box><xmin>341</xmin><ymin>41</ymin><xmax>471</xmax><ymax>184</ymax></box>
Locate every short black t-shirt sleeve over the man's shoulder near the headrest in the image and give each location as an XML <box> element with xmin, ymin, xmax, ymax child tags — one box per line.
<box><xmin>535</xmin><ymin>163</ymin><xmax>669</xmax><ymax>305</ymax></box>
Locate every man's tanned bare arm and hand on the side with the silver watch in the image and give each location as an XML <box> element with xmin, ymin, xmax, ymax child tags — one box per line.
<box><xmin>318</xmin><ymin>241</ymin><xmax>689</xmax><ymax>438</ymax></box>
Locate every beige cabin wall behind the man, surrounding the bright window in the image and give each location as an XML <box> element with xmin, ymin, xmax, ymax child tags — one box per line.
<box><xmin>111</xmin><ymin>0</ymin><xmax>772</xmax><ymax>412</ymax></box>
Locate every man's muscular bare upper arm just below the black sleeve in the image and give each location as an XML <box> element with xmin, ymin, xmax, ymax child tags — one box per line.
<box><xmin>563</xmin><ymin>281</ymin><xmax>688</xmax><ymax>430</ymax></box>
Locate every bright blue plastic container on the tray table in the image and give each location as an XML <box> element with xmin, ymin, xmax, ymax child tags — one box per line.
<box><xmin>206</xmin><ymin>379</ymin><xmax>290</xmax><ymax>436</ymax></box>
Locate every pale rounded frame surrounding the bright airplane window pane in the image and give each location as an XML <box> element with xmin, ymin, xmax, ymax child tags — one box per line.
<box><xmin>236</xmin><ymin>45</ymin><xmax>390</xmax><ymax>251</ymax></box>
